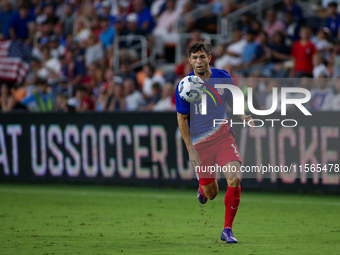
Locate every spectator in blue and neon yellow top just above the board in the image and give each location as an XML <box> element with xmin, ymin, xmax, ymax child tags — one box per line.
<box><xmin>21</xmin><ymin>78</ymin><xmax>56</xmax><ymax>112</ymax></box>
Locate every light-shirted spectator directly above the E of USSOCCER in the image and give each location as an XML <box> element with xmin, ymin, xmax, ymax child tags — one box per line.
<box><xmin>124</xmin><ymin>79</ymin><xmax>145</xmax><ymax>111</ymax></box>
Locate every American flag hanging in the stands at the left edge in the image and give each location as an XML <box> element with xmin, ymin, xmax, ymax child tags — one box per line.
<box><xmin>0</xmin><ymin>40</ymin><xmax>32</xmax><ymax>84</ymax></box>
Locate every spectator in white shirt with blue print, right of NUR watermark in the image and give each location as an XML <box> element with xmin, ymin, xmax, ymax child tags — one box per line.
<box><xmin>310</xmin><ymin>79</ymin><xmax>334</xmax><ymax>111</ymax></box>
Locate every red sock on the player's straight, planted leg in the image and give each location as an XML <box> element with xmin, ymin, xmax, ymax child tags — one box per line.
<box><xmin>224</xmin><ymin>186</ymin><xmax>241</xmax><ymax>229</ymax></box>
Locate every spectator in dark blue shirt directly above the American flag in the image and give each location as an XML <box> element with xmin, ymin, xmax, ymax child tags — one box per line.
<box><xmin>9</xmin><ymin>3</ymin><xmax>34</xmax><ymax>40</ymax></box>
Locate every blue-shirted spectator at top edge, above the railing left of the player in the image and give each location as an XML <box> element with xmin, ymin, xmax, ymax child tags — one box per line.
<box><xmin>133</xmin><ymin>0</ymin><xmax>156</xmax><ymax>34</ymax></box>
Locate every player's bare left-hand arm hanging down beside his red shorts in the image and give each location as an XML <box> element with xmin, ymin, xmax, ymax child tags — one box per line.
<box><xmin>177</xmin><ymin>112</ymin><xmax>200</xmax><ymax>168</ymax></box>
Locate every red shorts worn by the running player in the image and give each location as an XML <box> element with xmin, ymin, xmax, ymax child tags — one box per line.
<box><xmin>194</xmin><ymin>125</ymin><xmax>242</xmax><ymax>186</ymax></box>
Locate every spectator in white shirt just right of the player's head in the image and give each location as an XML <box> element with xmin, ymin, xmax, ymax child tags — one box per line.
<box><xmin>215</xmin><ymin>29</ymin><xmax>247</xmax><ymax>68</ymax></box>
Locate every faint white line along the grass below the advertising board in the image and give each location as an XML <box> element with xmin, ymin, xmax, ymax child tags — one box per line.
<box><xmin>0</xmin><ymin>187</ymin><xmax>340</xmax><ymax>206</ymax></box>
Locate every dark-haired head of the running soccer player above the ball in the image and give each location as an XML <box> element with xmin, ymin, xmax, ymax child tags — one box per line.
<box><xmin>188</xmin><ymin>41</ymin><xmax>211</xmax><ymax>75</ymax></box>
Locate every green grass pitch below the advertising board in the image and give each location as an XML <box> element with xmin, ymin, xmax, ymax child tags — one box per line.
<box><xmin>0</xmin><ymin>184</ymin><xmax>340</xmax><ymax>255</ymax></box>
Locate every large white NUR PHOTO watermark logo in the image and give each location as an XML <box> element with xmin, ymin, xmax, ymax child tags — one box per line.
<box><xmin>200</xmin><ymin>84</ymin><xmax>312</xmax><ymax>127</ymax></box>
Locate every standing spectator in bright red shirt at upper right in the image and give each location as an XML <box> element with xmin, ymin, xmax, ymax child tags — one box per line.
<box><xmin>290</xmin><ymin>26</ymin><xmax>317</xmax><ymax>78</ymax></box>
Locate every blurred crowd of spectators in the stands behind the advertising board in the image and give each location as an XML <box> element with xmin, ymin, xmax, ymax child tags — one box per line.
<box><xmin>0</xmin><ymin>0</ymin><xmax>340</xmax><ymax>112</ymax></box>
